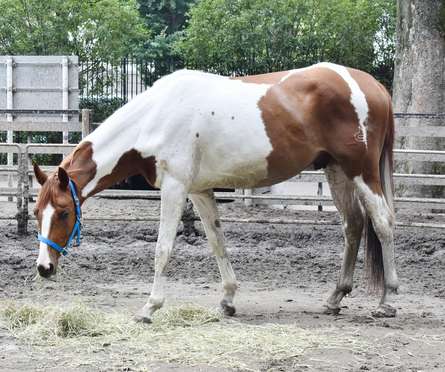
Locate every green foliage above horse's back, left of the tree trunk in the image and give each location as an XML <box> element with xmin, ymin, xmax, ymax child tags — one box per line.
<box><xmin>175</xmin><ymin>0</ymin><xmax>395</xmax><ymax>85</ymax></box>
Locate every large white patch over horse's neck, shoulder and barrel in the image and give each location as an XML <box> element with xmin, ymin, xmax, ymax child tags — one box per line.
<box><xmin>82</xmin><ymin>70</ymin><xmax>272</xmax><ymax>197</ymax></box>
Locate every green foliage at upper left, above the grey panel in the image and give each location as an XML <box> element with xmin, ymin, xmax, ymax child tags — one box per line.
<box><xmin>0</xmin><ymin>0</ymin><xmax>148</xmax><ymax>59</ymax></box>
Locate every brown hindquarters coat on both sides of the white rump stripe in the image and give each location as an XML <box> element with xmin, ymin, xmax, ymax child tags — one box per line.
<box><xmin>235</xmin><ymin>67</ymin><xmax>388</xmax><ymax>185</ymax></box>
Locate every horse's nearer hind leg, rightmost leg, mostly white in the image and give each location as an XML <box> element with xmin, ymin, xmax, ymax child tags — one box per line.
<box><xmin>353</xmin><ymin>176</ymin><xmax>399</xmax><ymax>317</ymax></box>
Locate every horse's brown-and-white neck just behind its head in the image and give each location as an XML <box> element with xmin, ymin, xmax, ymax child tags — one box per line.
<box><xmin>61</xmin><ymin>101</ymin><xmax>143</xmax><ymax>201</ymax></box>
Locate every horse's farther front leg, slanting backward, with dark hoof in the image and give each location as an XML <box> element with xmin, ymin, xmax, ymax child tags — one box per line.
<box><xmin>190</xmin><ymin>190</ymin><xmax>238</xmax><ymax>316</ymax></box>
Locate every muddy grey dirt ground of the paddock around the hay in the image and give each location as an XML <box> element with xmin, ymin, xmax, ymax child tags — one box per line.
<box><xmin>0</xmin><ymin>199</ymin><xmax>445</xmax><ymax>371</ymax></box>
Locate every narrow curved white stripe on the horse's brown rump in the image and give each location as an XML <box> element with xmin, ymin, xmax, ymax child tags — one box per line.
<box><xmin>313</xmin><ymin>62</ymin><xmax>369</xmax><ymax>146</ymax></box>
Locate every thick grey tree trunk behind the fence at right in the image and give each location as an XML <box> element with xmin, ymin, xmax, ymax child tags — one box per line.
<box><xmin>393</xmin><ymin>0</ymin><xmax>445</xmax><ymax>197</ymax></box>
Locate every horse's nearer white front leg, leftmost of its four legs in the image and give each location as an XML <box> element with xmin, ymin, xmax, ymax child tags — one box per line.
<box><xmin>136</xmin><ymin>175</ymin><xmax>187</xmax><ymax>323</ymax></box>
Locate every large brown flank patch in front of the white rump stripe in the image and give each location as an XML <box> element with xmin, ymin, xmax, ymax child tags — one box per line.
<box><xmin>250</xmin><ymin>67</ymin><xmax>364</xmax><ymax>183</ymax></box>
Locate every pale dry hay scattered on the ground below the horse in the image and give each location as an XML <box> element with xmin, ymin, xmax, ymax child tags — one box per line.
<box><xmin>0</xmin><ymin>303</ymin><xmax>365</xmax><ymax>370</ymax></box>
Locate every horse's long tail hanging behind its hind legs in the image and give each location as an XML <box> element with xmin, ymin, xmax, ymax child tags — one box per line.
<box><xmin>365</xmin><ymin>95</ymin><xmax>394</xmax><ymax>290</ymax></box>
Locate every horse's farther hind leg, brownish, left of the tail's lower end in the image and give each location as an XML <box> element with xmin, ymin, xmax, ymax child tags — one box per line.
<box><xmin>325</xmin><ymin>164</ymin><xmax>364</xmax><ymax>314</ymax></box>
